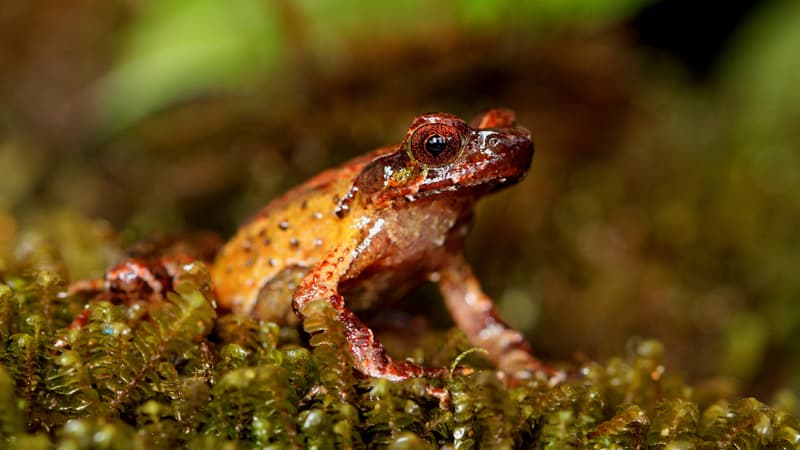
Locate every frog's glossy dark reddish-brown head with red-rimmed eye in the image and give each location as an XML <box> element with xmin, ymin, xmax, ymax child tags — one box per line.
<box><xmin>346</xmin><ymin>109</ymin><xmax>533</xmax><ymax>210</ymax></box>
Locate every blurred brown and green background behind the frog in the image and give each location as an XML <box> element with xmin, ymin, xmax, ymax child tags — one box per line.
<box><xmin>0</xmin><ymin>0</ymin><xmax>800</xmax><ymax>408</ymax></box>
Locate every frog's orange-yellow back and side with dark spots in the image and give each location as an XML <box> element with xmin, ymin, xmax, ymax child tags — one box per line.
<box><xmin>211</xmin><ymin>147</ymin><xmax>395</xmax><ymax>320</ymax></box>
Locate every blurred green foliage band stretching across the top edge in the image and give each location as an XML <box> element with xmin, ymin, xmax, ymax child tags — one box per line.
<box><xmin>99</xmin><ymin>0</ymin><xmax>652</xmax><ymax>129</ymax></box>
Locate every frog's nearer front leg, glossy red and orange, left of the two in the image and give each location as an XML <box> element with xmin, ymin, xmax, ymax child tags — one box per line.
<box><xmin>292</xmin><ymin>245</ymin><xmax>446</xmax><ymax>380</ymax></box>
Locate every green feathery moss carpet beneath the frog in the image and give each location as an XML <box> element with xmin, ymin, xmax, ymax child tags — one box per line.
<box><xmin>0</xmin><ymin>234</ymin><xmax>800</xmax><ymax>449</ymax></box>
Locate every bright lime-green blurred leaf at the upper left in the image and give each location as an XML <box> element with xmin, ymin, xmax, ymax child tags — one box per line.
<box><xmin>99</xmin><ymin>0</ymin><xmax>282</xmax><ymax>129</ymax></box>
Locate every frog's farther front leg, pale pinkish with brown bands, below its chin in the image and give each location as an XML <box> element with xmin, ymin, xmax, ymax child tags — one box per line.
<box><xmin>438</xmin><ymin>254</ymin><xmax>564</xmax><ymax>384</ymax></box>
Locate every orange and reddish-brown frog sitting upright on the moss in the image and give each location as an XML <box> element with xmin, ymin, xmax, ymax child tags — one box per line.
<box><xmin>210</xmin><ymin>108</ymin><xmax>560</xmax><ymax>382</ymax></box>
